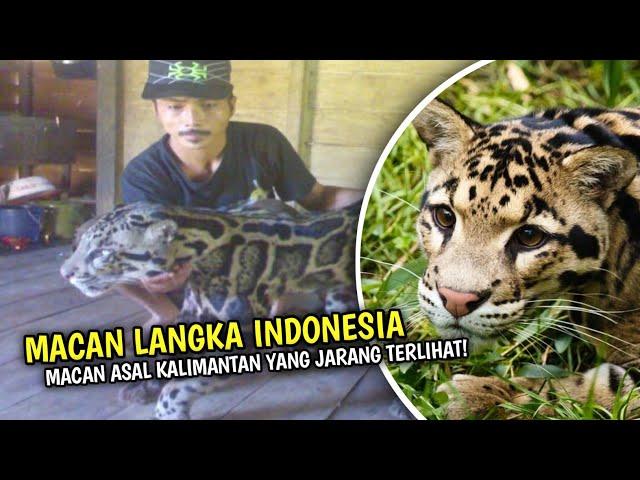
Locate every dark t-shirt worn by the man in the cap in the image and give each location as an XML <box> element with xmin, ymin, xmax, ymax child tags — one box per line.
<box><xmin>121</xmin><ymin>122</ymin><xmax>316</xmax><ymax>208</ymax></box>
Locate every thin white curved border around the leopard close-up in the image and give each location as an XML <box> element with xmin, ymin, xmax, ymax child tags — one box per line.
<box><xmin>355</xmin><ymin>60</ymin><xmax>494</xmax><ymax>420</ymax></box>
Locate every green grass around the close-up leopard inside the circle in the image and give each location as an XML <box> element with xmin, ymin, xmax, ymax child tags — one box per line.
<box><xmin>361</xmin><ymin>61</ymin><xmax>640</xmax><ymax>419</ymax></box>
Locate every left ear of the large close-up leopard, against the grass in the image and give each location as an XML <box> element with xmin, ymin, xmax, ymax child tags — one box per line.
<box><xmin>413</xmin><ymin>100</ymin><xmax>481</xmax><ymax>167</ymax></box>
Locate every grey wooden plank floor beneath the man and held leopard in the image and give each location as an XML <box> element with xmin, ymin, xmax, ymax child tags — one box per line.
<box><xmin>0</xmin><ymin>246</ymin><xmax>411</xmax><ymax>420</ymax></box>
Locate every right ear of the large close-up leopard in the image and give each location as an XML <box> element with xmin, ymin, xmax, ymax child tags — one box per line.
<box><xmin>562</xmin><ymin>146</ymin><xmax>638</xmax><ymax>203</ymax></box>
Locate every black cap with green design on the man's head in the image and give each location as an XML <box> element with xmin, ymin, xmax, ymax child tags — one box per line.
<box><xmin>142</xmin><ymin>60</ymin><xmax>233</xmax><ymax>99</ymax></box>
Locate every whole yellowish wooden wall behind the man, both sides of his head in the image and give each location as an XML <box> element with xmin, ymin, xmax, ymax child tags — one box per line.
<box><xmin>120</xmin><ymin>60</ymin><xmax>473</xmax><ymax>192</ymax></box>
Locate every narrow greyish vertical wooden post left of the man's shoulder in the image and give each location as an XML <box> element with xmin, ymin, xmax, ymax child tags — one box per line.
<box><xmin>96</xmin><ymin>60</ymin><xmax>121</xmax><ymax>215</ymax></box>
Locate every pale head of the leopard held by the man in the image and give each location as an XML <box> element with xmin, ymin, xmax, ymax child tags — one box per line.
<box><xmin>60</xmin><ymin>204</ymin><xmax>178</xmax><ymax>297</ymax></box>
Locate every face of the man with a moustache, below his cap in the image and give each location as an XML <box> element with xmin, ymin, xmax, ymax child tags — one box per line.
<box><xmin>155</xmin><ymin>97</ymin><xmax>235</xmax><ymax>149</ymax></box>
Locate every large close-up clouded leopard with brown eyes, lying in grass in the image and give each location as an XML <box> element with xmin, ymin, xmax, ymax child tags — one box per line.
<box><xmin>413</xmin><ymin>100</ymin><xmax>640</xmax><ymax>419</ymax></box>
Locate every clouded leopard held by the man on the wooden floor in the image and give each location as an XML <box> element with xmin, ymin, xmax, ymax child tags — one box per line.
<box><xmin>61</xmin><ymin>199</ymin><xmax>360</xmax><ymax>419</ymax></box>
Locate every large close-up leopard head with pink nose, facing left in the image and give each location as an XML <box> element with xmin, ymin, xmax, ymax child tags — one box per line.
<box><xmin>413</xmin><ymin>101</ymin><xmax>637</xmax><ymax>350</ymax></box>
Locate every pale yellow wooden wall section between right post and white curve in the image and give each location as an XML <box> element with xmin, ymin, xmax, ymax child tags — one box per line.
<box><xmin>309</xmin><ymin>60</ymin><xmax>470</xmax><ymax>188</ymax></box>
